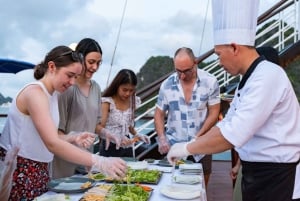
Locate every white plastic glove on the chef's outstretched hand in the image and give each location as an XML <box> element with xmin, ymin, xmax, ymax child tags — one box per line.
<box><xmin>167</xmin><ymin>142</ymin><xmax>191</xmax><ymax>164</ymax></box>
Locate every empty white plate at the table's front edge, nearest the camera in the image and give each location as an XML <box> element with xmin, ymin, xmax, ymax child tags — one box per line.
<box><xmin>160</xmin><ymin>185</ymin><xmax>201</xmax><ymax>200</ymax></box>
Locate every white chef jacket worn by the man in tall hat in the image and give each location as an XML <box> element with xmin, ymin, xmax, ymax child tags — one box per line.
<box><xmin>217</xmin><ymin>60</ymin><xmax>300</xmax><ymax>197</ymax></box>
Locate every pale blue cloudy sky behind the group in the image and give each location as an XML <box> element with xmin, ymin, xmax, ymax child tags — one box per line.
<box><xmin>0</xmin><ymin>0</ymin><xmax>279</xmax><ymax>97</ymax></box>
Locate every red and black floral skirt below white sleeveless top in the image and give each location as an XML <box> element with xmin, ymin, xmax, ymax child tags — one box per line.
<box><xmin>0</xmin><ymin>147</ymin><xmax>49</xmax><ymax>201</ymax></box>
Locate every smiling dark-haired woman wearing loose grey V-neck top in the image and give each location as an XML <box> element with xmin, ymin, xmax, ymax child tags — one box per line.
<box><xmin>52</xmin><ymin>38</ymin><xmax>119</xmax><ymax>178</ymax></box>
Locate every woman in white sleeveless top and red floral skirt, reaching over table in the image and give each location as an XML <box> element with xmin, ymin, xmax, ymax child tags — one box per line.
<box><xmin>0</xmin><ymin>46</ymin><xmax>126</xmax><ymax>200</ymax></box>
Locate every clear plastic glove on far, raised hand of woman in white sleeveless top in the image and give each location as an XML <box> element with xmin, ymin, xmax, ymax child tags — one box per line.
<box><xmin>68</xmin><ymin>131</ymin><xmax>97</xmax><ymax>149</ymax></box>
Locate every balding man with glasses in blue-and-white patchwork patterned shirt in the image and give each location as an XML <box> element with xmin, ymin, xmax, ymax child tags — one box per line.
<box><xmin>154</xmin><ymin>47</ymin><xmax>220</xmax><ymax>186</ymax></box>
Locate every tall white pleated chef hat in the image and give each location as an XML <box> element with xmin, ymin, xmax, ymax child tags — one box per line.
<box><xmin>212</xmin><ymin>0</ymin><xmax>259</xmax><ymax>46</ymax></box>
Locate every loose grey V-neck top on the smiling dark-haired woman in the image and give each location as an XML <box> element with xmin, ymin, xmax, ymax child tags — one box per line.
<box><xmin>50</xmin><ymin>80</ymin><xmax>101</xmax><ymax>179</ymax></box>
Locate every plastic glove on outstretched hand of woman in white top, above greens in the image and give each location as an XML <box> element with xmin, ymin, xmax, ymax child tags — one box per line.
<box><xmin>91</xmin><ymin>154</ymin><xmax>127</xmax><ymax>180</ymax></box>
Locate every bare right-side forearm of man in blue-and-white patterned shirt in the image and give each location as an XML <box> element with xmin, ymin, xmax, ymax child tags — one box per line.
<box><xmin>196</xmin><ymin>103</ymin><xmax>221</xmax><ymax>137</ymax></box>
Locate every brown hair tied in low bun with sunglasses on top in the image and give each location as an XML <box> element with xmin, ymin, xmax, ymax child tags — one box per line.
<box><xmin>33</xmin><ymin>45</ymin><xmax>82</xmax><ymax>80</ymax></box>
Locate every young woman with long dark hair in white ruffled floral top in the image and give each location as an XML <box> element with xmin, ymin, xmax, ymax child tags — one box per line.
<box><xmin>100</xmin><ymin>69</ymin><xmax>150</xmax><ymax>157</ymax></box>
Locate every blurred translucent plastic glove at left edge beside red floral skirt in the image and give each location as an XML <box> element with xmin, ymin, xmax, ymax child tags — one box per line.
<box><xmin>0</xmin><ymin>147</ymin><xmax>19</xmax><ymax>200</ymax></box>
